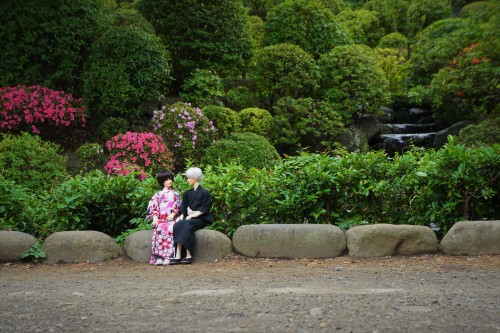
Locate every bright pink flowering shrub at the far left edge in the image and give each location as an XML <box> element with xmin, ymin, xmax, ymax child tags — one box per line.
<box><xmin>0</xmin><ymin>85</ymin><xmax>85</xmax><ymax>134</ymax></box>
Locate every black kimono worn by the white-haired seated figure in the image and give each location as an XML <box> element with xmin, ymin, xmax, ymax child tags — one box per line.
<box><xmin>174</xmin><ymin>185</ymin><xmax>212</xmax><ymax>256</ymax></box>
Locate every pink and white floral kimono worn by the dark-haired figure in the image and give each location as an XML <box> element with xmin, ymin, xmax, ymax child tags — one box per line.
<box><xmin>147</xmin><ymin>189</ymin><xmax>181</xmax><ymax>265</ymax></box>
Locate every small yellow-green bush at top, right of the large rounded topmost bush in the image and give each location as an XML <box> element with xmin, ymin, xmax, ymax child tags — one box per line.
<box><xmin>337</xmin><ymin>9</ymin><xmax>384</xmax><ymax>47</ymax></box>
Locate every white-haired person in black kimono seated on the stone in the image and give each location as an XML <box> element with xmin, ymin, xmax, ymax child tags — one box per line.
<box><xmin>170</xmin><ymin>168</ymin><xmax>212</xmax><ymax>265</ymax></box>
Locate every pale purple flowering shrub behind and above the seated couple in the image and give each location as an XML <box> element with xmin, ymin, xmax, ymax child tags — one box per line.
<box><xmin>153</xmin><ymin>102</ymin><xmax>216</xmax><ymax>167</ymax></box>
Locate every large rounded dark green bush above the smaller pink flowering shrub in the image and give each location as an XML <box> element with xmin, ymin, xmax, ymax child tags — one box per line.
<box><xmin>83</xmin><ymin>26</ymin><xmax>170</xmax><ymax>122</ymax></box>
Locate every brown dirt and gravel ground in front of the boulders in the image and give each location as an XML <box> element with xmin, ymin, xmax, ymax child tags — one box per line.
<box><xmin>0</xmin><ymin>254</ymin><xmax>500</xmax><ymax>333</ymax></box>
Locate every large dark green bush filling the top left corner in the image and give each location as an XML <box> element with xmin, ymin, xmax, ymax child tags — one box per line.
<box><xmin>0</xmin><ymin>0</ymin><xmax>112</xmax><ymax>97</ymax></box>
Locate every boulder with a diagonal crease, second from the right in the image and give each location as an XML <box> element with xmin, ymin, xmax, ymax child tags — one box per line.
<box><xmin>346</xmin><ymin>224</ymin><xmax>439</xmax><ymax>257</ymax></box>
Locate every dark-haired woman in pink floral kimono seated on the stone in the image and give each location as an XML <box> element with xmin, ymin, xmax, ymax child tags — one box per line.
<box><xmin>147</xmin><ymin>170</ymin><xmax>181</xmax><ymax>265</ymax></box>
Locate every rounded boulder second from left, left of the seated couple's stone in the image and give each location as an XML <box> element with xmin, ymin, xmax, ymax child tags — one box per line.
<box><xmin>44</xmin><ymin>231</ymin><xmax>122</xmax><ymax>264</ymax></box>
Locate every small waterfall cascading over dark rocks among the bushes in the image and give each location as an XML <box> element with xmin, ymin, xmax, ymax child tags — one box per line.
<box><xmin>371</xmin><ymin>108</ymin><xmax>440</xmax><ymax>156</ymax></box>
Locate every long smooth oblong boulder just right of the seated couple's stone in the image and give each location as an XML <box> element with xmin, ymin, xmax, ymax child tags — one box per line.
<box><xmin>233</xmin><ymin>224</ymin><xmax>346</xmax><ymax>258</ymax></box>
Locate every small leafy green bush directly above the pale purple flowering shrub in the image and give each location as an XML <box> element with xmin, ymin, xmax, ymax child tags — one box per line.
<box><xmin>179</xmin><ymin>69</ymin><xmax>224</xmax><ymax>108</ymax></box>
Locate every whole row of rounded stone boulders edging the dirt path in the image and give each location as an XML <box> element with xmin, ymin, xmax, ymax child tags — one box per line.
<box><xmin>0</xmin><ymin>221</ymin><xmax>500</xmax><ymax>264</ymax></box>
